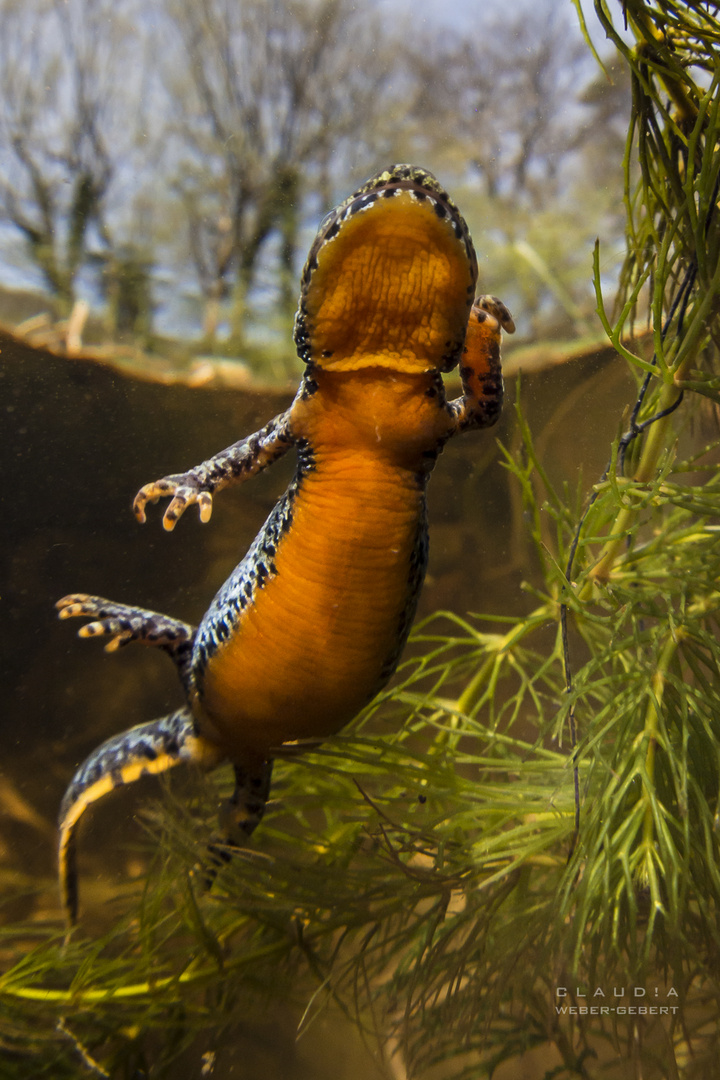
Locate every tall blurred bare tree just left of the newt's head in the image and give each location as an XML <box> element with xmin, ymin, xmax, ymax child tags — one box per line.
<box><xmin>166</xmin><ymin>0</ymin><xmax>397</xmax><ymax>336</ymax></box>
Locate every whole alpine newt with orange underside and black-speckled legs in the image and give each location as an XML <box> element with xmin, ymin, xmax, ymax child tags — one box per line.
<box><xmin>57</xmin><ymin>165</ymin><xmax>514</xmax><ymax>921</ymax></box>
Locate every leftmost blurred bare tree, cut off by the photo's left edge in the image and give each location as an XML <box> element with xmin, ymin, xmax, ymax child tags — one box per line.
<box><xmin>0</xmin><ymin>0</ymin><xmax>144</xmax><ymax>312</ymax></box>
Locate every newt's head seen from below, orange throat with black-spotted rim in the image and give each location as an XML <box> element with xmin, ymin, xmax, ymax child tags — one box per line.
<box><xmin>295</xmin><ymin>165</ymin><xmax>477</xmax><ymax>375</ymax></box>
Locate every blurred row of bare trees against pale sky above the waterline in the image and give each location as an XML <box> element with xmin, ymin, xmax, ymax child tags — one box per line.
<box><xmin>0</xmin><ymin>0</ymin><xmax>628</xmax><ymax>364</ymax></box>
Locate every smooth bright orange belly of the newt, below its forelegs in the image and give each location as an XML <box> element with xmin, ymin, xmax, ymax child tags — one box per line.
<box><xmin>197</xmin><ymin>458</ymin><xmax>423</xmax><ymax>761</ymax></box>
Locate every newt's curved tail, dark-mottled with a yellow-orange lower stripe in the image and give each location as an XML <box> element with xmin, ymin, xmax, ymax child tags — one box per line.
<box><xmin>58</xmin><ymin>708</ymin><xmax>223</xmax><ymax>923</ymax></box>
